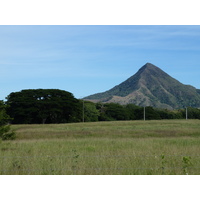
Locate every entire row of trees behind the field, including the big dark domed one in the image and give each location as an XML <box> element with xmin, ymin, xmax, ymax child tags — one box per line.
<box><xmin>1</xmin><ymin>89</ymin><xmax>200</xmax><ymax>124</ymax></box>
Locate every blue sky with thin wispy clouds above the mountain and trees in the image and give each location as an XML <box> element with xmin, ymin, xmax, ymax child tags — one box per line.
<box><xmin>0</xmin><ymin>25</ymin><xmax>200</xmax><ymax>99</ymax></box>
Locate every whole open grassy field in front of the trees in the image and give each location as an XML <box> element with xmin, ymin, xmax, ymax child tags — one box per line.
<box><xmin>0</xmin><ymin>120</ymin><xmax>200</xmax><ymax>175</ymax></box>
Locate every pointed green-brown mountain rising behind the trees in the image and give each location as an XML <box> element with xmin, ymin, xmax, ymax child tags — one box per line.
<box><xmin>84</xmin><ymin>63</ymin><xmax>200</xmax><ymax>109</ymax></box>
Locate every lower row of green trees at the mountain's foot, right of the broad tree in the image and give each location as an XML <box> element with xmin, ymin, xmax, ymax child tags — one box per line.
<box><xmin>85</xmin><ymin>102</ymin><xmax>200</xmax><ymax>122</ymax></box>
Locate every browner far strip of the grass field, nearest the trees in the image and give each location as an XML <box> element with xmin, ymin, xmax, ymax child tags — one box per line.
<box><xmin>13</xmin><ymin>120</ymin><xmax>200</xmax><ymax>140</ymax></box>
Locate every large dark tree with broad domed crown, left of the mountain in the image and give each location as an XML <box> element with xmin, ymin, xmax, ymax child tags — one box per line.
<box><xmin>7</xmin><ymin>89</ymin><xmax>81</xmax><ymax>124</ymax></box>
